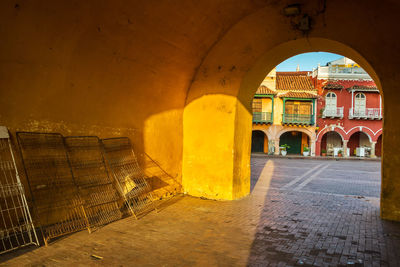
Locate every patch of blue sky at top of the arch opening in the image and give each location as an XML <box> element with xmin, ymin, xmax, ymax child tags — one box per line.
<box><xmin>276</xmin><ymin>52</ymin><xmax>343</xmax><ymax>71</ymax></box>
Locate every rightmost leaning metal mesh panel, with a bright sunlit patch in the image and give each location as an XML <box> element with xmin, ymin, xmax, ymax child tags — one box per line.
<box><xmin>101</xmin><ymin>137</ymin><xmax>156</xmax><ymax>218</ymax></box>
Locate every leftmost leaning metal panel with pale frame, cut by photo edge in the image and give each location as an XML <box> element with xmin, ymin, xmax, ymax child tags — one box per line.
<box><xmin>0</xmin><ymin>126</ymin><xmax>39</xmax><ymax>254</ymax></box>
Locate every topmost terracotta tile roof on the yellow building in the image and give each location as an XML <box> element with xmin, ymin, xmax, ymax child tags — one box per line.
<box><xmin>276</xmin><ymin>71</ymin><xmax>314</xmax><ymax>91</ymax></box>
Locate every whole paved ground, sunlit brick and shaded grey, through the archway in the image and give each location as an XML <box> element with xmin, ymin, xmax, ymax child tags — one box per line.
<box><xmin>0</xmin><ymin>157</ymin><xmax>400</xmax><ymax>266</ymax></box>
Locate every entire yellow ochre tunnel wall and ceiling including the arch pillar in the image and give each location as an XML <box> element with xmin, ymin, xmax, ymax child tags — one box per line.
<box><xmin>0</xmin><ymin>0</ymin><xmax>400</xmax><ymax>220</ymax></box>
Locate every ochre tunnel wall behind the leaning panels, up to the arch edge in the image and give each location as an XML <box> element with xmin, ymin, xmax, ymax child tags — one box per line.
<box><xmin>0</xmin><ymin>0</ymin><xmax>268</xmax><ymax>199</ymax></box>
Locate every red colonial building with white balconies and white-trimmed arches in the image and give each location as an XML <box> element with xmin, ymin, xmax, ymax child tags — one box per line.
<box><xmin>312</xmin><ymin>57</ymin><xmax>382</xmax><ymax>157</ymax></box>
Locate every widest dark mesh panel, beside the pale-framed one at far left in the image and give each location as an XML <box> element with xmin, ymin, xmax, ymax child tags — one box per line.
<box><xmin>17</xmin><ymin>132</ymin><xmax>89</xmax><ymax>245</ymax></box>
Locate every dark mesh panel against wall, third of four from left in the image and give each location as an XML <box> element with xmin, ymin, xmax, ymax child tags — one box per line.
<box><xmin>65</xmin><ymin>136</ymin><xmax>122</xmax><ymax>227</ymax></box>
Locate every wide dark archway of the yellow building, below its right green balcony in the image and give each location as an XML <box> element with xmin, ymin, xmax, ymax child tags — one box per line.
<box><xmin>279</xmin><ymin>131</ymin><xmax>310</xmax><ymax>155</ymax></box>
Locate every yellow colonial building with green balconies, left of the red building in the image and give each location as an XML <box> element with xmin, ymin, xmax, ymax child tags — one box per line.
<box><xmin>252</xmin><ymin>69</ymin><xmax>318</xmax><ymax>155</ymax></box>
